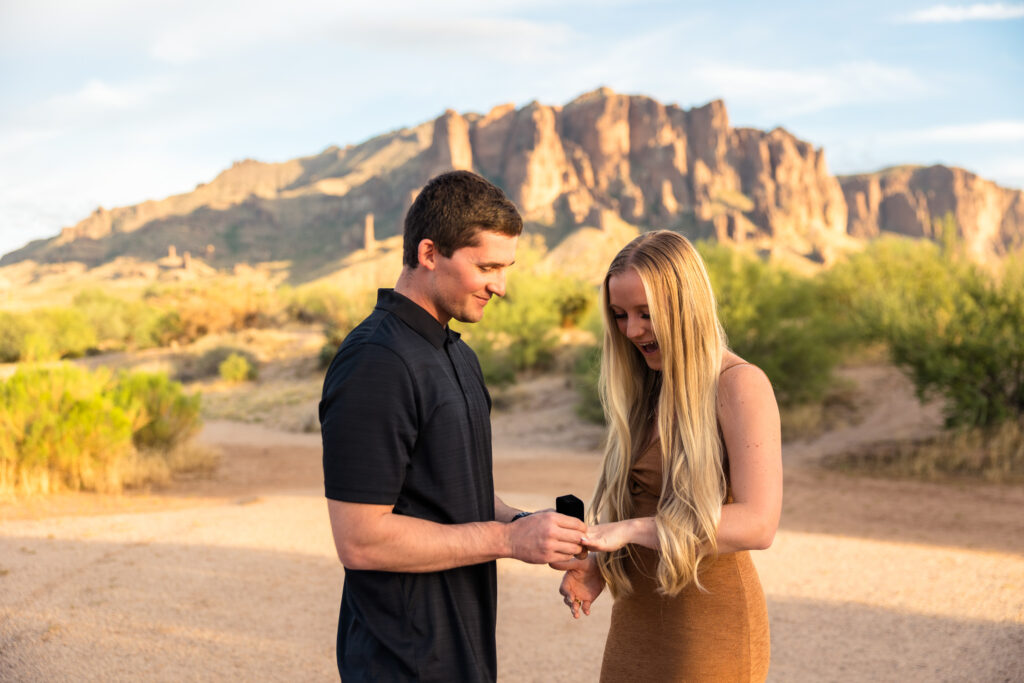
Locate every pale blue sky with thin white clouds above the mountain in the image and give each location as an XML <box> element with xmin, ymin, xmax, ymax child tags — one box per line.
<box><xmin>0</xmin><ymin>0</ymin><xmax>1024</xmax><ymax>259</ymax></box>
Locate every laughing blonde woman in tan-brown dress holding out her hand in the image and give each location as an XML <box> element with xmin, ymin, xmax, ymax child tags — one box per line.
<box><xmin>557</xmin><ymin>230</ymin><xmax>782</xmax><ymax>683</ymax></box>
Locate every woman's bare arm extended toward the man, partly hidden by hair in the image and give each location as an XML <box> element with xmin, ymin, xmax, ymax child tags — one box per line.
<box><xmin>583</xmin><ymin>365</ymin><xmax>782</xmax><ymax>553</ymax></box>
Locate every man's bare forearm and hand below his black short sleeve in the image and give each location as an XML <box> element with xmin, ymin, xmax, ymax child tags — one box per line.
<box><xmin>328</xmin><ymin>500</ymin><xmax>587</xmax><ymax>571</ymax></box>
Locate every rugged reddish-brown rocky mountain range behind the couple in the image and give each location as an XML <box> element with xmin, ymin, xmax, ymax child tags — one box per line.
<box><xmin>0</xmin><ymin>88</ymin><xmax>1024</xmax><ymax>271</ymax></box>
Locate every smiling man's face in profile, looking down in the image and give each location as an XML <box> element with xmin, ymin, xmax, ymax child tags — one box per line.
<box><xmin>432</xmin><ymin>230</ymin><xmax>519</xmax><ymax>323</ymax></box>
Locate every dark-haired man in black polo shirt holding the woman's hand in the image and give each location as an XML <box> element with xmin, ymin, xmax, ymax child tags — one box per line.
<box><xmin>319</xmin><ymin>171</ymin><xmax>586</xmax><ymax>683</ymax></box>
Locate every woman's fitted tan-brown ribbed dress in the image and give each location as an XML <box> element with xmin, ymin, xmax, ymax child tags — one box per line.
<box><xmin>601</xmin><ymin>441</ymin><xmax>769</xmax><ymax>683</ymax></box>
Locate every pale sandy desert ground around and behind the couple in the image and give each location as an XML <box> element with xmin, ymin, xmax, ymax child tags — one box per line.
<box><xmin>0</xmin><ymin>369</ymin><xmax>1024</xmax><ymax>682</ymax></box>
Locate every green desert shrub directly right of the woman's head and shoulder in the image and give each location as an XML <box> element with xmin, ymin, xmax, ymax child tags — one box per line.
<box><xmin>699</xmin><ymin>243</ymin><xmax>855</xmax><ymax>405</ymax></box>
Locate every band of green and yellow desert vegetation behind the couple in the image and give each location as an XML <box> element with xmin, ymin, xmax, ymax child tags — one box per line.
<box><xmin>0</xmin><ymin>231</ymin><xmax>1024</xmax><ymax>490</ymax></box>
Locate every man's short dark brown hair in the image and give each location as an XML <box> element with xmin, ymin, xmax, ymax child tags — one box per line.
<box><xmin>401</xmin><ymin>171</ymin><xmax>522</xmax><ymax>268</ymax></box>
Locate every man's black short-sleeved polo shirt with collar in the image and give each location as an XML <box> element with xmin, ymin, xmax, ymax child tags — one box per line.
<box><xmin>319</xmin><ymin>290</ymin><xmax>497</xmax><ymax>683</ymax></box>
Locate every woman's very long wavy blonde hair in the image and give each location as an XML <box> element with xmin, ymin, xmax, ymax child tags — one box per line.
<box><xmin>590</xmin><ymin>230</ymin><xmax>726</xmax><ymax>595</ymax></box>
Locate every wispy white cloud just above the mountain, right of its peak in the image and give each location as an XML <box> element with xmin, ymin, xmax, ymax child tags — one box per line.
<box><xmin>693</xmin><ymin>61</ymin><xmax>930</xmax><ymax>117</ymax></box>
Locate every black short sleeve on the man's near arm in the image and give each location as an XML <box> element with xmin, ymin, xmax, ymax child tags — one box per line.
<box><xmin>319</xmin><ymin>344</ymin><xmax>419</xmax><ymax>505</ymax></box>
